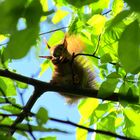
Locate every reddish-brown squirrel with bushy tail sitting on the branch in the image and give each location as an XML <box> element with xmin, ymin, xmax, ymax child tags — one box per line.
<box><xmin>40</xmin><ymin>34</ymin><xmax>96</xmax><ymax>104</ymax></box>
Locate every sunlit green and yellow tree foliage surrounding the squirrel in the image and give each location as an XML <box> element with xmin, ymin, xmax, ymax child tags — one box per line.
<box><xmin>0</xmin><ymin>0</ymin><xmax>140</xmax><ymax>140</ymax></box>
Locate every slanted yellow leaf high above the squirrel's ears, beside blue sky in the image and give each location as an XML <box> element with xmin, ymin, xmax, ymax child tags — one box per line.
<box><xmin>52</xmin><ymin>10</ymin><xmax>69</xmax><ymax>24</ymax></box>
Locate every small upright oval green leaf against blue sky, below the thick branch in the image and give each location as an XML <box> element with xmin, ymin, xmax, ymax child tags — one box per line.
<box><xmin>36</xmin><ymin>107</ymin><xmax>48</xmax><ymax>125</ymax></box>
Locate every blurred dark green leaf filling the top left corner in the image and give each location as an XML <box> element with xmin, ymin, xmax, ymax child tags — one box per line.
<box><xmin>0</xmin><ymin>0</ymin><xmax>27</xmax><ymax>34</ymax></box>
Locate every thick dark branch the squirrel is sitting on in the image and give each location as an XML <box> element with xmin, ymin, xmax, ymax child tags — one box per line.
<box><xmin>0</xmin><ymin>70</ymin><xmax>138</xmax><ymax>103</ymax></box>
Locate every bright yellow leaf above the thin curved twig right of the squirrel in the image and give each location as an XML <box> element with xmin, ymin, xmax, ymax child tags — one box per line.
<box><xmin>87</xmin><ymin>14</ymin><xmax>106</xmax><ymax>35</ymax></box>
